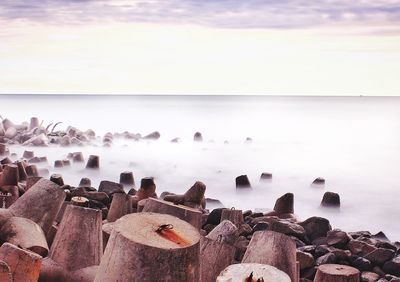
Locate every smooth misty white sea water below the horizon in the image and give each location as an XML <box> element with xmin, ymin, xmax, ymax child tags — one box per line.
<box><xmin>0</xmin><ymin>95</ymin><xmax>400</xmax><ymax>241</ymax></box>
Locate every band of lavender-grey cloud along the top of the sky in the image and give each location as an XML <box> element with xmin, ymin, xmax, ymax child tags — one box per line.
<box><xmin>0</xmin><ymin>0</ymin><xmax>400</xmax><ymax>28</ymax></box>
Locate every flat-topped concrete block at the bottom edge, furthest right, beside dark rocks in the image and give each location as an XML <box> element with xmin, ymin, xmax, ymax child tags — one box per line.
<box><xmin>314</xmin><ymin>264</ymin><xmax>360</xmax><ymax>282</ymax></box>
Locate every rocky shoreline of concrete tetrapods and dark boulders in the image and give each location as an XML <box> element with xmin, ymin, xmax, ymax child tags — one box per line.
<box><xmin>0</xmin><ymin>118</ymin><xmax>400</xmax><ymax>282</ymax></box>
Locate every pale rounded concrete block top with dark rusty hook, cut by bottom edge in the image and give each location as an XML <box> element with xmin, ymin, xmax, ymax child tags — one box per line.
<box><xmin>217</xmin><ymin>263</ymin><xmax>295</xmax><ymax>282</ymax></box>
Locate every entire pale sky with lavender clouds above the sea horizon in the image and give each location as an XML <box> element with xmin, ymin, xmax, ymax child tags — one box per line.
<box><xmin>0</xmin><ymin>0</ymin><xmax>400</xmax><ymax>96</ymax></box>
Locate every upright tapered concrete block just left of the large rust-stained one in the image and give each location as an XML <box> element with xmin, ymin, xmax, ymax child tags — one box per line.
<box><xmin>49</xmin><ymin>205</ymin><xmax>103</xmax><ymax>271</ymax></box>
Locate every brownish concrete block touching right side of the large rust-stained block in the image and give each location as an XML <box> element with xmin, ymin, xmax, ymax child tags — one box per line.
<box><xmin>200</xmin><ymin>237</ymin><xmax>236</xmax><ymax>282</ymax></box>
